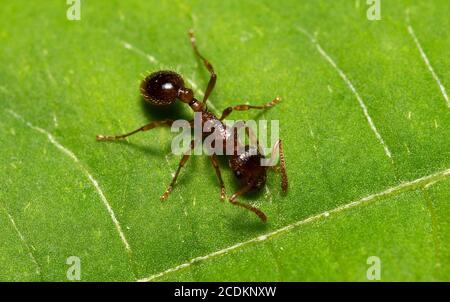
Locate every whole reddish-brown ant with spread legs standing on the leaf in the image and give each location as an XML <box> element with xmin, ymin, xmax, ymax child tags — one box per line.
<box><xmin>96</xmin><ymin>30</ymin><xmax>288</xmax><ymax>222</ymax></box>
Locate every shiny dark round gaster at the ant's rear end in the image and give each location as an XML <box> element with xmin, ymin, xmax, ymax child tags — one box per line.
<box><xmin>141</xmin><ymin>70</ymin><xmax>184</xmax><ymax>105</ymax></box>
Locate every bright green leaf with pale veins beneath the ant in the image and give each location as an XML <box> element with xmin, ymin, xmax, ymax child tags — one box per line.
<box><xmin>0</xmin><ymin>0</ymin><xmax>450</xmax><ymax>281</ymax></box>
